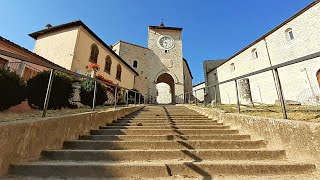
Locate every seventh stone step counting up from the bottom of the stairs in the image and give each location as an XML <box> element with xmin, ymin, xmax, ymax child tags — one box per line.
<box><xmin>106</xmin><ymin>122</ymin><xmax>223</xmax><ymax>126</ymax></box>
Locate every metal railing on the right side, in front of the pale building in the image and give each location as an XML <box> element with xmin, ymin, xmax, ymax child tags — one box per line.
<box><xmin>178</xmin><ymin>52</ymin><xmax>320</xmax><ymax>119</ymax></box>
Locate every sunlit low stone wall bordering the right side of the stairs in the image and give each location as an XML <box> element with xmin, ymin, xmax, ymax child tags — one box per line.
<box><xmin>186</xmin><ymin>105</ymin><xmax>320</xmax><ymax>165</ymax></box>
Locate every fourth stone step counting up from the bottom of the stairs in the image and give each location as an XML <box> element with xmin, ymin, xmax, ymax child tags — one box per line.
<box><xmin>80</xmin><ymin>134</ymin><xmax>250</xmax><ymax>141</ymax></box>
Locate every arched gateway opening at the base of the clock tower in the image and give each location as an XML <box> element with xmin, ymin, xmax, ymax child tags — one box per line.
<box><xmin>156</xmin><ymin>73</ymin><xmax>176</xmax><ymax>104</ymax></box>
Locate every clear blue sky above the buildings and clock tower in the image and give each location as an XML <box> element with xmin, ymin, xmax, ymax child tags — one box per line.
<box><xmin>0</xmin><ymin>0</ymin><xmax>313</xmax><ymax>84</ymax></box>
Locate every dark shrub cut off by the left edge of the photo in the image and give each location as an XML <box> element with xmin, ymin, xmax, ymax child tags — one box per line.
<box><xmin>0</xmin><ymin>69</ymin><xmax>26</xmax><ymax>110</ymax></box>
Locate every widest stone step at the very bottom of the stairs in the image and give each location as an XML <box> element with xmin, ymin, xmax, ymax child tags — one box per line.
<box><xmin>10</xmin><ymin>160</ymin><xmax>316</xmax><ymax>179</ymax></box>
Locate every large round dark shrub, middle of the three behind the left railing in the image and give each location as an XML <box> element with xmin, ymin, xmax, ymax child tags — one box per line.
<box><xmin>27</xmin><ymin>71</ymin><xmax>73</xmax><ymax>109</ymax></box>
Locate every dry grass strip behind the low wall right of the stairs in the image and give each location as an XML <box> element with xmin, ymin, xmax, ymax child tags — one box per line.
<box><xmin>199</xmin><ymin>104</ymin><xmax>320</xmax><ymax>122</ymax></box>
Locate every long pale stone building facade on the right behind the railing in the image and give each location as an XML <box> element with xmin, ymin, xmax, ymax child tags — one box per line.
<box><xmin>205</xmin><ymin>1</ymin><xmax>320</xmax><ymax>104</ymax></box>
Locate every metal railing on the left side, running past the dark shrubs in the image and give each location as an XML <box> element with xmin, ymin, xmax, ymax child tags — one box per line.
<box><xmin>0</xmin><ymin>49</ymin><xmax>156</xmax><ymax>117</ymax></box>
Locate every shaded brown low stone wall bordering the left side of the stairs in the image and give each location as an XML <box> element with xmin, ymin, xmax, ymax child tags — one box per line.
<box><xmin>0</xmin><ymin>106</ymin><xmax>143</xmax><ymax>175</ymax></box>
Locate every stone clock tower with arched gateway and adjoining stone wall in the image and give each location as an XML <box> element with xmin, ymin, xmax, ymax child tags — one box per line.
<box><xmin>113</xmin><ymin>24</ymin><xmax>193</xmax><ymax>104</ymax></box>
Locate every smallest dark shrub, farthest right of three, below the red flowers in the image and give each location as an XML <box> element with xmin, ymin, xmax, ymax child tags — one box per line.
<box><xmin>80</xmin><ymin>79</ymin><xmax>108</xmax><ymax>107</ymax></box>
